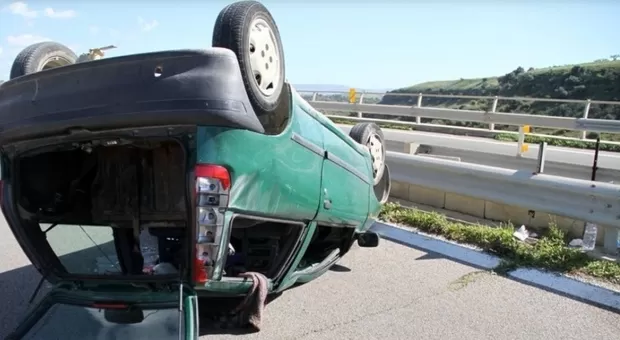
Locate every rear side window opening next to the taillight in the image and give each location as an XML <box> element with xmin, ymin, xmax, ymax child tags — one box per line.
<box><xmin>224</xmin><ymin>217</ymin><xmax>303</xmax><ymax>279</ymax></box>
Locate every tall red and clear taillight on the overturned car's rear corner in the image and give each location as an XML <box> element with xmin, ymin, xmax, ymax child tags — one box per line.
<box><xmin>194</xmin><ymin>164</ymin><xmax>231</xmax><ymax>283</ymax></box>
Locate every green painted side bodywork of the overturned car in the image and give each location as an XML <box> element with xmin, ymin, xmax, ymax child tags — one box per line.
<box><xmin>197</xmin><ymin>87</ymin><xmax>381</xmax><ymax>294</ymax></box>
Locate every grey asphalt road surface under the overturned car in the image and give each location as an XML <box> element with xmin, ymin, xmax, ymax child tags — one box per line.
<box><xmin>0</xmin><ymin>216</ymin><xmax>620</xmax><ymax>340</ymax></box>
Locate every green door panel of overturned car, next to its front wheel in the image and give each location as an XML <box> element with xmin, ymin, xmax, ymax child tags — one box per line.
<box><xmin>317</xmin><ymin>128</ymin><xmax>372</xmax><ymax>228</ymax></box>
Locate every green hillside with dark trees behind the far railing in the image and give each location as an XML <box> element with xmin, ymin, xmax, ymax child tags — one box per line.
<box><xmin>380</xmin><ymin>60</ymin><xmax>620</xmax><ymax>140</ymax></box>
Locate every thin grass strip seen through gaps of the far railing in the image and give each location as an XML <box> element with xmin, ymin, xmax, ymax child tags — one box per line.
<box><xmin>329</xmin><ymin>117</ymin><xmax>620</xmax><ymax>152</ymax></box>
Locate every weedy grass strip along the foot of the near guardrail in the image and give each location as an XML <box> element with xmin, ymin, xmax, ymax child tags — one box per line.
<box><xmin>379</xmin><ymin>203</ymin><xmax>620</xmax><ymax>284</ymax></box>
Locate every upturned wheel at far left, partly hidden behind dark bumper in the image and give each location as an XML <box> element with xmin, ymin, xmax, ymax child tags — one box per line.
<box><xmin>10</xmin><ymin>41</ymin><xmax>77</xmax><ymax>79</ymax></box>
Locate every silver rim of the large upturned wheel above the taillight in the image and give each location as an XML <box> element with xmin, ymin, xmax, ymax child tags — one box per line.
<box><xmin>247</xmin><ymin>18</ymin><xmax>282</xmax><ymax>97</ymax></box>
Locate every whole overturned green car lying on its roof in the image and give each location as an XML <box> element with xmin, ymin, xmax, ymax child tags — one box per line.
<box><xmin>0</xmin><ymin>1</ymin><xmax>390</xmax><ymax>339</ymax></box>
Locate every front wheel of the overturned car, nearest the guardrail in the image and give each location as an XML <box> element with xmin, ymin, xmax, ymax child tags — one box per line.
<box><xmin>349</xmin><ymin>123</ymin><xmax>386</xmax><ymax>185</ymax></box>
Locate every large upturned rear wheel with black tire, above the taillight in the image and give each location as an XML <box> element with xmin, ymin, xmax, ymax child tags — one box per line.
<box><xmin>212</xmin><ymin>1</ymin><xmax>286</xmax><ymax>115</ymax></box>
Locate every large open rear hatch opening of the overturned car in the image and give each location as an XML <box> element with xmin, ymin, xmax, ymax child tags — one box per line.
<box><xmin>13</xmin><ymin>133</ymin><xmax>190</xmax><ymax>276</ymax></box>
